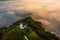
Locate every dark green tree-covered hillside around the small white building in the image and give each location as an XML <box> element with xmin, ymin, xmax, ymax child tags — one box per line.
<box><xmin>0</xmin><ymin>17</ymin><xmax>60</xmax><ymax>40</ymax></box>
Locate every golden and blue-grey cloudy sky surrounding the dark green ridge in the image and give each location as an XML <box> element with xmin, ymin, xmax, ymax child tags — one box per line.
<box><xmin>0</xmin><ymin>0</ymin><xmax>60</xmax><ymax>36</ymax></box>
